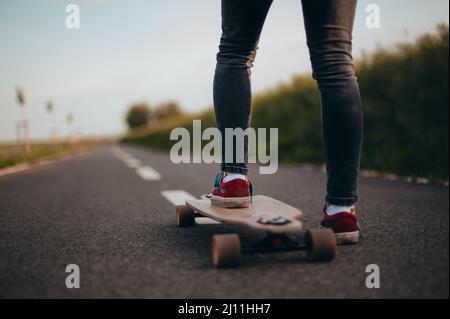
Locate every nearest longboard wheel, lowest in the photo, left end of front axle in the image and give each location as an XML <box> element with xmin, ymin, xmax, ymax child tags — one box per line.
<box><xmin>212</xmin><ymin>234</ymin><xmax>241</xmax><ymax>268</ymax></box>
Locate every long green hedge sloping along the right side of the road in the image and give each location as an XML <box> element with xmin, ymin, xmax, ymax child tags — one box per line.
<box><xmin>124</xmin><ymin>25</ymin><xmax>449</xmax><ymax>180</ymax></box>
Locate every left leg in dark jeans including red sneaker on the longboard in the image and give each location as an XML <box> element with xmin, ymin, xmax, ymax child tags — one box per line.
<box><xmin>211</xmin><ymin>0</ymin><xmax>272</xmax><ymax>208</ymax></box>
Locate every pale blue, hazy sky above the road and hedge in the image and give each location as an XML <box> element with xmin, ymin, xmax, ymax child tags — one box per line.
<box><xmin>0</xmin><ymin>0</ymin><xmax>449</xmax><ymax>141</ymax></box>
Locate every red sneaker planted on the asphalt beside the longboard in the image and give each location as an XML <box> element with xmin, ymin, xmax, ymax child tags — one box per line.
<box><xmin>320</xmin><ymin>204</ymin><xmax>359</xmax><ymax>245</ymax></box>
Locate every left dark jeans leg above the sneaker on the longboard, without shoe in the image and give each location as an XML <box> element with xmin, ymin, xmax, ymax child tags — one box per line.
<box><xmin>214</xmin><ymin>0</ymin><xmax>272</xmax><ymax>175</ymax></box>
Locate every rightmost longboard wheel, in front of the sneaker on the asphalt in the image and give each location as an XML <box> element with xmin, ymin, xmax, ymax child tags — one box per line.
<box><xmin>305</xmin><ymin>229</ymin><xmax>336</xmax><ymax>262</ymax></box>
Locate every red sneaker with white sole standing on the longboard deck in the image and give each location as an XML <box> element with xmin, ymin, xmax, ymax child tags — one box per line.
<box><xmin>211</xmin><ymin>172</ymin><xmax>252</xmax><ymax>208</ymax></box>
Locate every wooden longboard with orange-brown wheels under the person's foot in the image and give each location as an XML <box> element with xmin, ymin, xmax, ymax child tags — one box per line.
<box><xmin>177</xmin><ymin>195</ymin><xmax>336</xmax><ymax>268</ymax></box>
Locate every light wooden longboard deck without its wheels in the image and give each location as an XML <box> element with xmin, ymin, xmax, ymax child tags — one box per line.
<box><xmin>186</xmin><ymin>195</ymin><xmax>303</xmax><ymax>234</ymax></box>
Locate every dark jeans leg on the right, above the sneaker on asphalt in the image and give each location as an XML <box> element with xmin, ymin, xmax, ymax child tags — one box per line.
<box><xmin>302</xmin><ymin>0</ymin><xmax>363</xmax><ymax>206</ymax></box>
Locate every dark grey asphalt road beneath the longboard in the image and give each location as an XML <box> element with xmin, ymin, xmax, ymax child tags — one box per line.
<box><xmin>0</xmin><ymin>146</ymin><xmax>449</xmax><ymax>298</ymax></box>
